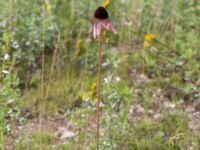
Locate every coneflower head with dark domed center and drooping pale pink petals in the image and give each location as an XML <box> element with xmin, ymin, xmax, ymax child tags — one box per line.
<box><xmin>92</xmin><ymin>6</ymin><xmax>117</xmax><ymax>38</ymax></box>
